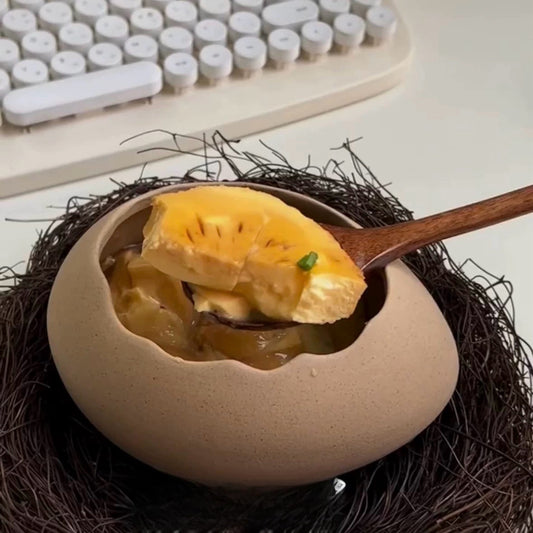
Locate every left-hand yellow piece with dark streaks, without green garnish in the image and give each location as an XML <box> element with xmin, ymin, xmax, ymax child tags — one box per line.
<box><xmin>142</xmin><ymin>187</ymin><xmax>265</xmax><ymax>291</ymax></box>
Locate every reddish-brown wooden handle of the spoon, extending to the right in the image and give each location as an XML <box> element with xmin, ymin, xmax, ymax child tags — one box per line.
<box><xmin>354</xmin><ymin>185</ymin><xmax>533</xmax><ymax>271</ymax></box>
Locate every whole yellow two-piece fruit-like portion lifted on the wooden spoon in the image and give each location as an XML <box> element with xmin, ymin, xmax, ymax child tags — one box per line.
<box><xmin>142</xmin><ymin>186</ymin><xmax>366</xmax><ymax>324</ymax></box>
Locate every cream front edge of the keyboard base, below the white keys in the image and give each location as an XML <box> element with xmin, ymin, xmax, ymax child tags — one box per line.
<box><xmin>0</xmin><ymin>1</ymin><xmax>412</xmax><ymax>198</ymax></box>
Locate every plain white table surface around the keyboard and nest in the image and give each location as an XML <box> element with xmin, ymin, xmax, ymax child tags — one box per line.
<box><xmin>0</xmin><ymin>0</ymin><xmax>533</xmax><ymax>342</ymax></box>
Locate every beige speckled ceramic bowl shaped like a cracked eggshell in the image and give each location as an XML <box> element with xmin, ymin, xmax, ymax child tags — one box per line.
<box><xmin>48</xmin><ymin>183</ymin><xmax>458</xmax><ymax>487</ymax></box>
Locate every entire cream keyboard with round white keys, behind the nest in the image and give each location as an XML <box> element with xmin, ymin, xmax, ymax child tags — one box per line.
<box><xmin>0</xmin><ymin>0</ymin><xmax>412</xmax><ymax>198</ymax></box>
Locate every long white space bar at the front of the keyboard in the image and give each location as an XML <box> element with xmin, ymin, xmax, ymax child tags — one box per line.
<box><xmin>4</xmin><ymin>60</ymin><xmax>163</xmax><ymax>126</ymax></box>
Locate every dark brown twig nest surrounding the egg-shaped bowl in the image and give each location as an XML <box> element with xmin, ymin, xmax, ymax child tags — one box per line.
<box><xmin>0</xmin><ymin>136</ymin><xmax>533</xmax><ymax>533</ymax></box>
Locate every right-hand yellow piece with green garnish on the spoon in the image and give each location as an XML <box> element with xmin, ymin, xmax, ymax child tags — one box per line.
<box><xmin>235</xmin><ymin>204</ymin><xmax>366</xmax><ymax>324</ymax></box>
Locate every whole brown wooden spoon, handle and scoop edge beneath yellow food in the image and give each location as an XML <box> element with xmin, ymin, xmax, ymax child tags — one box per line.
<box><xmin>188</xmin><ymin>185</ymin><xmax>533</xmax><ymax>330</ymax></box>
